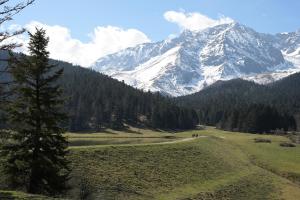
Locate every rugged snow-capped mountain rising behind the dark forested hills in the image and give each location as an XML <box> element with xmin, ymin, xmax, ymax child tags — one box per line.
<box><xmin>91</xmin><ymin>22</ymin><xmax>300</xmax><ymax>96</ymax></box>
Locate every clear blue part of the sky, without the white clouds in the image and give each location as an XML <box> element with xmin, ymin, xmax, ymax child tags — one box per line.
<box><xmin>15</xmin><ymin>0</ymin><xmax>300</xmax><ymax>41</ymax></box>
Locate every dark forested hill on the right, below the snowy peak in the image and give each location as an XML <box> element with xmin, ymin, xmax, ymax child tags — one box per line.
<box><xmin>177</xmin><ymin>77</ymin><xmax>300</xmax><ymax>133</ymax></box>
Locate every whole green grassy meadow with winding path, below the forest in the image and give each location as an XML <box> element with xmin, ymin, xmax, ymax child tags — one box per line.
<box><xmin>0</xmin><ymin>128</ymin><xmax>300</xmax><ymax>200</ymax></box>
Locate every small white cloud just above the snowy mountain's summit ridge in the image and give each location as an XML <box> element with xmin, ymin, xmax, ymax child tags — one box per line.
<box><xmin>164</xmin><ymin>11</ymin><xmax>233</xmax><ymax>31</ymax></box>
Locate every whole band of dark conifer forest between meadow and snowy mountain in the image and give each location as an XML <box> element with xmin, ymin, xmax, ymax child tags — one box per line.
<box><xmin>1</xmin><ymin>53</ymin><xmax>300</xmax><ymax>133</ymax></box>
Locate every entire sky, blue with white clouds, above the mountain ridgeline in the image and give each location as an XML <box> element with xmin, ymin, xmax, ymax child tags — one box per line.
<box><xmin>8</xmin><ymin>0</ymin><xmax>300</xmax><ymax>67</ymax></box>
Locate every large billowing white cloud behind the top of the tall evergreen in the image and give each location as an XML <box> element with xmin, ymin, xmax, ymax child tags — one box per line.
<box><xmin>15</xmin><ymin>21</ymin><xmax>150</xmax><ymax>67</ymax></box>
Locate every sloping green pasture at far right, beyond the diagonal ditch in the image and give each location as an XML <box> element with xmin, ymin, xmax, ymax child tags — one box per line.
<box><xmin>202</xmin><ymin>131</ymin><xmax>300</xmax><ymax>184</ymax></box>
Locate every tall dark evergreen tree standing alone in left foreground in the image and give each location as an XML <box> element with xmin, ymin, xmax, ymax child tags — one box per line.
<box><xmin>3</xmin><ymin>29</ymin><xmax>69</xmax><ymax>195</ymax></box>
